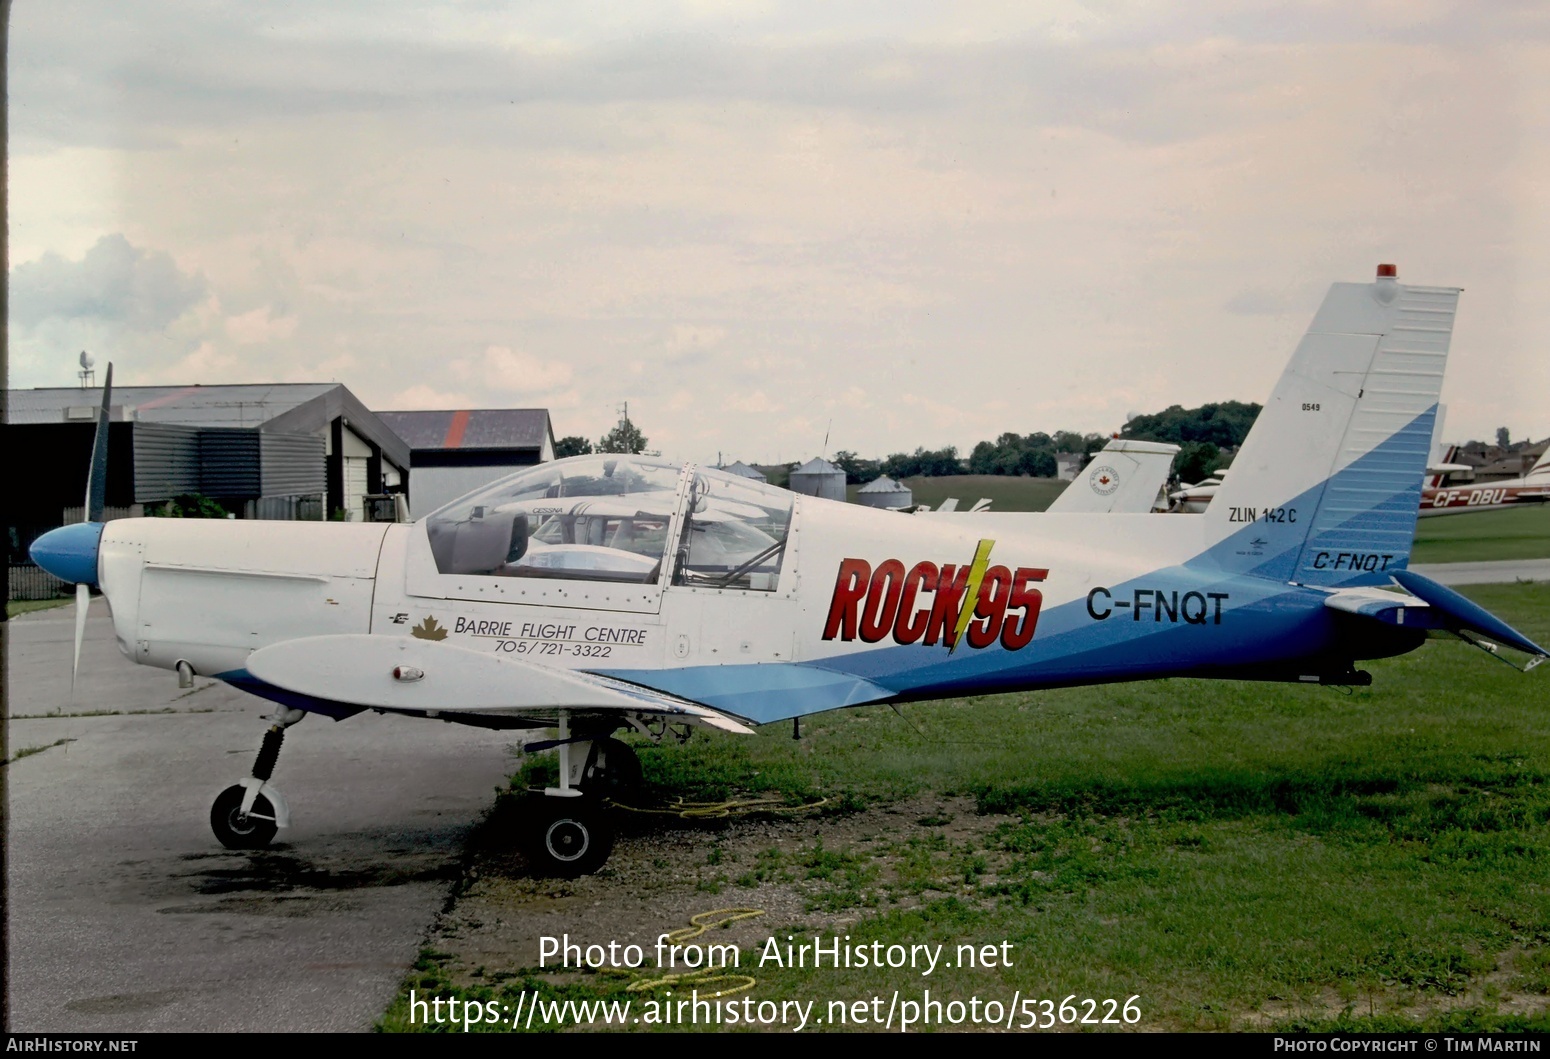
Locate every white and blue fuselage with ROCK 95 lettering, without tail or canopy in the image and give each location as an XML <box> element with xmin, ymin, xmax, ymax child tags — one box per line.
<box><xmin>84</xmin><ymin>468</ymin><xmax>1414</xmax><ymax>723</ymax></box>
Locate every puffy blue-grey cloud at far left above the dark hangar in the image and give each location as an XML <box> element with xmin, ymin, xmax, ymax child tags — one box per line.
<box><xmin>11</xmin><ymin>234</ymin><xmax>206</xmax><ymax>330</ymax></box>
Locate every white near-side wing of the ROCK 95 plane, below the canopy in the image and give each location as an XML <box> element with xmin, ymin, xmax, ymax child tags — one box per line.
<box><xmin>248</xmin><ymin>634</ymin><xmax>750</xmax><ymax>733</ymax></box>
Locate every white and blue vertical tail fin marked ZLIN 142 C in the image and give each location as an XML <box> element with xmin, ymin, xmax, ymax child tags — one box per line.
<box><xmin>1201</xmin><ymin>265</ymin><xmax>1459</xmax><ymax>586</ymax></box>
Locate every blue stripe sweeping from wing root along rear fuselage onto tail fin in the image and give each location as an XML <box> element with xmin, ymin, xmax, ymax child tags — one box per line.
<box><xmin>603</xmin><ymin>406</ymin><xmax>1435</xmax><ymax>723</ymax></box>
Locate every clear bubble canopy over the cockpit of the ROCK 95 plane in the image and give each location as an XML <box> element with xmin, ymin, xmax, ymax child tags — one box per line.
<box><xmin>425</xmin><ymin>454</ymin><xmax>794</xmax><ymax>592</ymax></box>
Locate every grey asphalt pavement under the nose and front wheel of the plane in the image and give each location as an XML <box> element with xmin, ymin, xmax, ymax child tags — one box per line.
<box><xmin>5</xmin><ymin>600</ymin><xmax>513</xmax><ymax>1033</ymax></box>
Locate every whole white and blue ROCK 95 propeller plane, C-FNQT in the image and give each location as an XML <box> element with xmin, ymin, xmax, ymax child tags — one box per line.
<box><xmin>34</xmin><ymin>267</ymin><xmax>1545</xmax><ymax>874</ymax></box>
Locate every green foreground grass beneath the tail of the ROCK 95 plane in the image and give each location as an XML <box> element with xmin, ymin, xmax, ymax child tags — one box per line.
<box><xmin>384</xmin><ymin>585</ymin><xmax>1550</xmax><ymax>1031</ymax></box>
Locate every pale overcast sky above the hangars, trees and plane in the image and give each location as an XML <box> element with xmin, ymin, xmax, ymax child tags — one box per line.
<box><xmin>9</xmin><ymin>0</ymin><xmax>1550</xmax><ymax>462</ymax></box>
